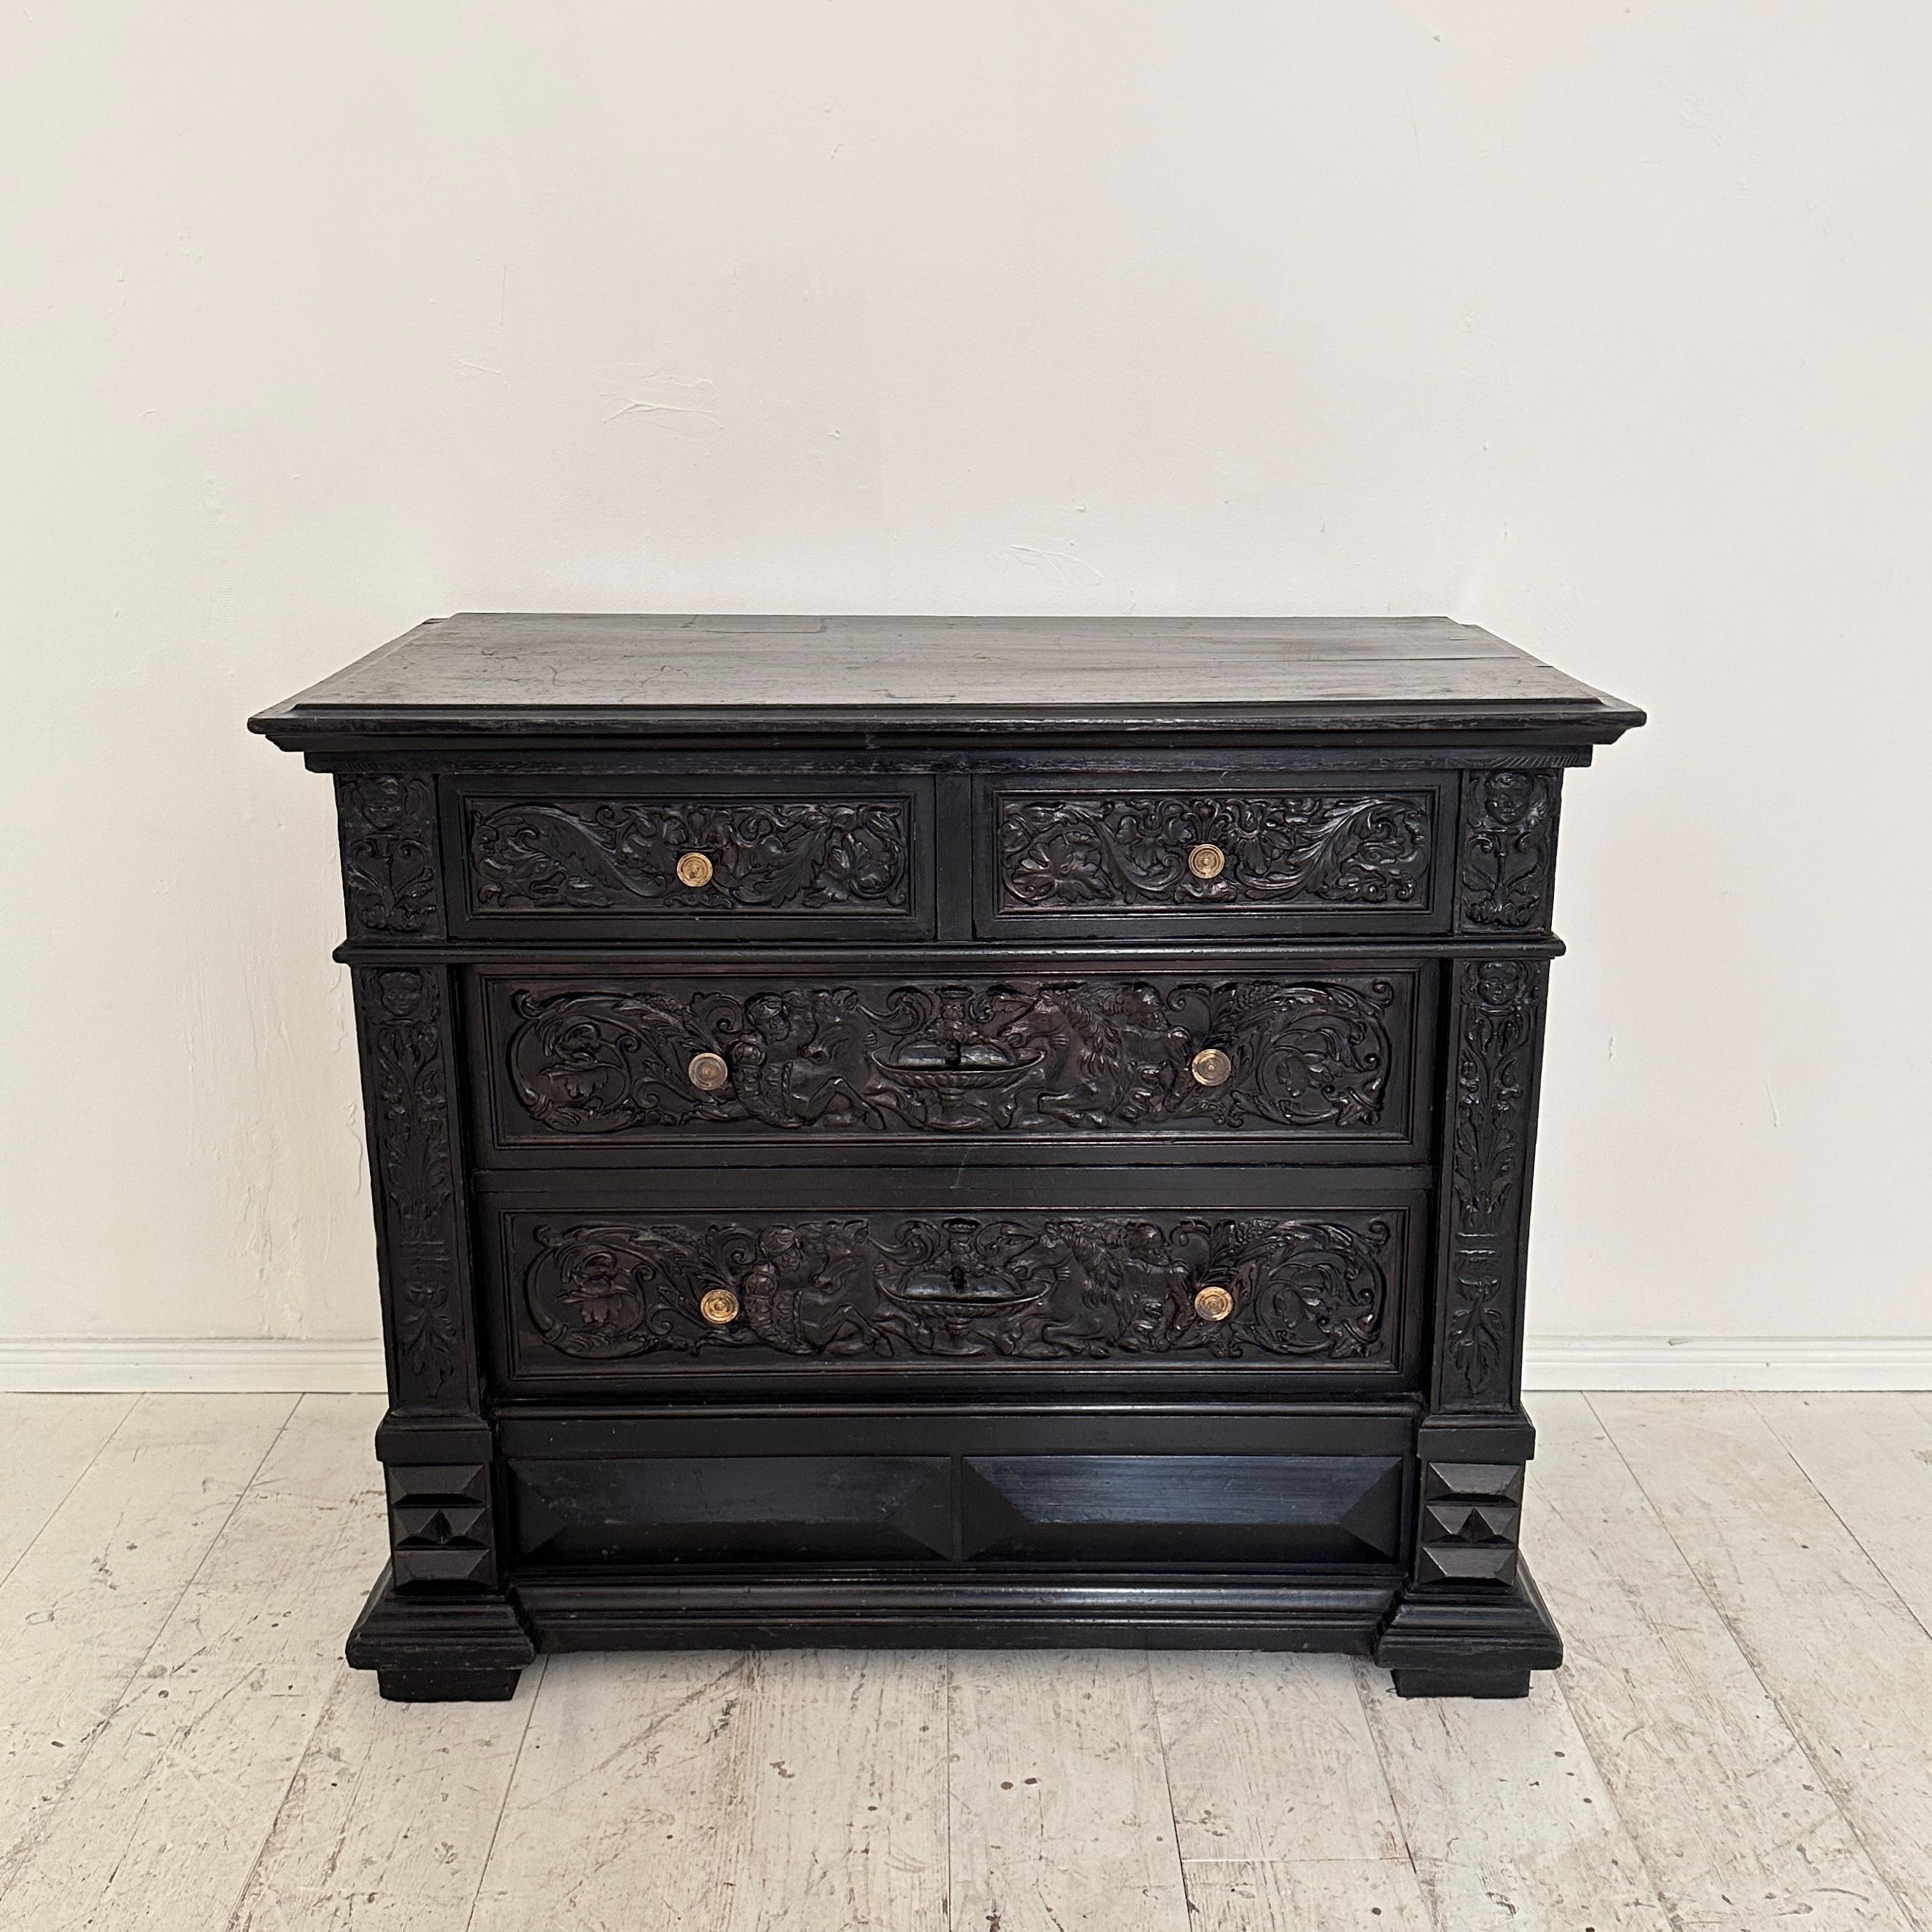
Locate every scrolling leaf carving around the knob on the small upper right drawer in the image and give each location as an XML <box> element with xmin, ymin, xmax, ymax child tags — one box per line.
<box><xmin>999</xmin><ymin>792</ymin><xmax>1434</xmax><ymax>910</ymax></box>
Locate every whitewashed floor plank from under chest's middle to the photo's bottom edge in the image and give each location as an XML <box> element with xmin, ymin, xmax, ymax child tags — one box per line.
<box><xmin>948</xmin><ymin>1650</ymin><xmax>1189</xmax><ymax>1932</ymax></box>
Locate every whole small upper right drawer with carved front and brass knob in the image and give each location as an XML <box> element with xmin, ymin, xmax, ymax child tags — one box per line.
<box><xmin>975</xmin><ymin>773</ymin><xmax>1455</xmax><ymax>937</ymax></box>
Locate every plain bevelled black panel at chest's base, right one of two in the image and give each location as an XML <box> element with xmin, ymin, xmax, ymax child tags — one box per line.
<box><xmin>960</xmin><ymin>1455</ymin><xmax>1402</xmax><ymax>1563</ymax></box>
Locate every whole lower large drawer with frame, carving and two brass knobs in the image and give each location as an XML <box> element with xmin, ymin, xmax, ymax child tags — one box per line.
<box><xmin>483</xmin><ymin>1169</ymin><xmax>1428</xmax><ymax>1395</ymax></box>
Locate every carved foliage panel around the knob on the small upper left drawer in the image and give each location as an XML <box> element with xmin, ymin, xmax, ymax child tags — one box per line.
<box><xmin>468</xmin><ymin>798</ymin><xmax>912</xmax><ymax>916</ymax></box>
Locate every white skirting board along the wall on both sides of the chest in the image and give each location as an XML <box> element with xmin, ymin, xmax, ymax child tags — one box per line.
<box><xmin>0</xmin><ymin>1335</ymin><xmax>1932</xmax><ymax>1395</ymax></box>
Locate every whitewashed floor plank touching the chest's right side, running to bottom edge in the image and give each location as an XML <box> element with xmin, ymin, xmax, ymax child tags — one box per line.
<box><xmin>1530</xmin><ymin>1395</ymin><xmax>1913</xmax><ymax>1932</ymax></box>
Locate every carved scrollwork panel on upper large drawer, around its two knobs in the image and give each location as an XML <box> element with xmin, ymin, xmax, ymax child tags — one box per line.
<box><xmin>506</xmin><ymin>974</ymin><xmax>1408</xmax><ymax>1134</ymax></box>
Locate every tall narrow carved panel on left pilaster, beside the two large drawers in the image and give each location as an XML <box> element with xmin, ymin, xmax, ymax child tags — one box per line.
<box><xmin>355</xmin><ymin>966</ymin><xmax>469</xmax><ymax>1408</ymax></box>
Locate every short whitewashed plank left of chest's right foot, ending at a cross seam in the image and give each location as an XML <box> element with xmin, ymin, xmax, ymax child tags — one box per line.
<box><xmin>1150</xmin><ymin>1650</ymin><xmax>1408</xmax><ymax>1863</ymax></box>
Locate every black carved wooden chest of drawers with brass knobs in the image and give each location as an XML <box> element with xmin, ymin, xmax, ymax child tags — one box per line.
<box><xmin>253</xmin><ymin>617</ymin><xmax>1642</xmax><ymax>1699</ymax></box>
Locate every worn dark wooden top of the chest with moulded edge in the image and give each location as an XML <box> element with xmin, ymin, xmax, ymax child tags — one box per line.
<box><xmin>253</xmin><ymin>612</ymin><xmax>1642</xmax><ymax>743</ymax></box>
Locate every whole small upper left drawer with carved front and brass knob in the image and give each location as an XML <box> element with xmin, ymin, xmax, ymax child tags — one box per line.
<box><xmin>447</xmin><ymin>776</ymin><xmax>933</xmax><ymax>939</ymax></box>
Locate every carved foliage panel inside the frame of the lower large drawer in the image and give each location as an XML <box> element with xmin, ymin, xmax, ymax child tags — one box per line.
<box><xmin>508</xmin><ymin>1210</ymin><xmax>1407</xmax><ymax>1368</ymax></box>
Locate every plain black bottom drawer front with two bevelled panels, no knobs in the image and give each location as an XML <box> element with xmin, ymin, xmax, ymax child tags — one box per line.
<box><xmin>506</xmin><ymin>1413</ymin><xmax>1408</xmax><ymax>1569</ymax></box>
